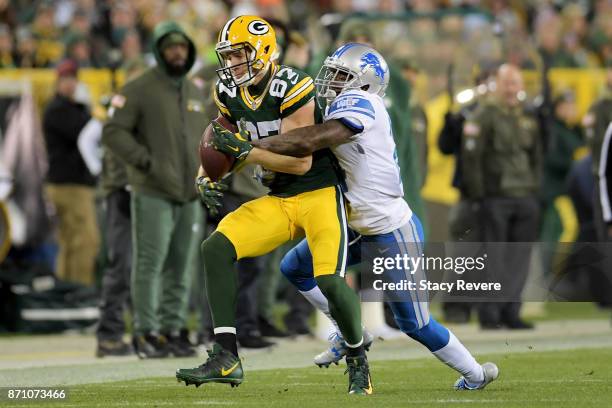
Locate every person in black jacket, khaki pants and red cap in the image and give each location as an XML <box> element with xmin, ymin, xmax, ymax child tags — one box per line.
<box><xmin>43</xmin><ymin>60</ymin><xmax>100</xmax><ymax>286</ymax></box>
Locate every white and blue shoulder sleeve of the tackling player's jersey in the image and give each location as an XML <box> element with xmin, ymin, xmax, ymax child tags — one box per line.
<box><xmin>325</xmin><ymin>93</ymin><xmax>376</xmax><ymax>133</ymax></box>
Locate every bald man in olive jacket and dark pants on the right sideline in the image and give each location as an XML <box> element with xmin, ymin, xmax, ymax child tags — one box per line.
<box><xmin>461</xmin><ymin>64</ymin><xmax>542</xmax><ymax>329</ymax></box>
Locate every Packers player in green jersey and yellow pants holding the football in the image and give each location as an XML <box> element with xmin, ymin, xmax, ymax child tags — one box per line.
<box><xmin>176</xmin><ymin>16</ymin><xmax>372</xmax><ymax>395</ymax></box>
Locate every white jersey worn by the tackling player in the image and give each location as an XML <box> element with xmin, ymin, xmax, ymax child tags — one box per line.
<box><xmin>325</xmin><ymin>90</ymin><xmax>412</xmax><ymax>235</ymax></box>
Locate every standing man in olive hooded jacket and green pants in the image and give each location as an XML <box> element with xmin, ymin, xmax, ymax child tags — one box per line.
<box><xmin>102</xmin><ymin>21</ymin><xmax>208</xmax><ymax>358</ymax></box>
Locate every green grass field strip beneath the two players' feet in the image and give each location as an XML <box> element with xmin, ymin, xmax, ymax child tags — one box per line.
<box><xmin>5</xmin><ymin>349</ymin><xmax>612</xmax><ymax>408</ymax></box>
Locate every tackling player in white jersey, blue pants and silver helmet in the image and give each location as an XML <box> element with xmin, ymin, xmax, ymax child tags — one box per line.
<box><xmin>213</xmin><ymin>43</ymin><xmax>499</xmax><ymax>390</ymax></box>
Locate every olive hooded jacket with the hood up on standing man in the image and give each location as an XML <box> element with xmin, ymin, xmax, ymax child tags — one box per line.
<box><xmin>102</xmin><ymin>22</ymin><xmax>208</xmax><ymax>203</ymax></box>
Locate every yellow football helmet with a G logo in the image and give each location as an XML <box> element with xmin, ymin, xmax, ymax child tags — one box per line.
<box><xmin>215</xmin><ymin>16</ymin><xmax>276</xmax><ymax>87</ymax></box>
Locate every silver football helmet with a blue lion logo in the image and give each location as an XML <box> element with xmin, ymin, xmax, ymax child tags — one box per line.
<box><xmin>315</xmin><ymin>43</ymin><xmax>389</xmax><ymax>102</ymax></box>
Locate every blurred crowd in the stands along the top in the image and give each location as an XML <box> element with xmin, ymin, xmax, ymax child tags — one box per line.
<box><xmin>0</xmin><ymin>0</ymin><xmax>612</xmax><ymax>68</ymax></box>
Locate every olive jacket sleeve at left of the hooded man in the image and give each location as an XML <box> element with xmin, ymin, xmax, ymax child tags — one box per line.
<box><xmin>102</xmin><ymin>88</ymin><xmax>151</xmax><ymax>170</ymax></box>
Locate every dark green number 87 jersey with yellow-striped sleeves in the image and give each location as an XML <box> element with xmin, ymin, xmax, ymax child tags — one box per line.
<box><xmin>214</xmin><ymin>64</ymin><xmax>339</xmax><ymax>197</ymax></box>
